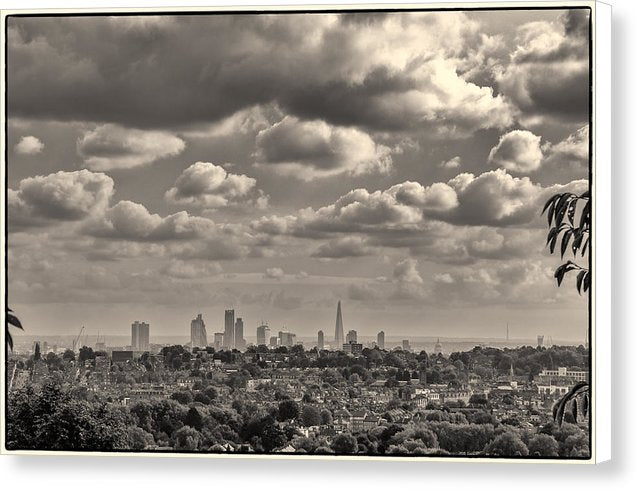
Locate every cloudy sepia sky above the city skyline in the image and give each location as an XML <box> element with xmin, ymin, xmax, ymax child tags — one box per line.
<box><xmin>7</xmin><ymin>9</ymin><xmax>589</xmax><ymax>341</ymax></box>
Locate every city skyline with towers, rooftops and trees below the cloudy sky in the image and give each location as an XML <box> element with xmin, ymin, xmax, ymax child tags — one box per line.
<box><xmin>6</xmin><ymin>302</ymin><xmax>589</xmax><ymax>458</ymax></box>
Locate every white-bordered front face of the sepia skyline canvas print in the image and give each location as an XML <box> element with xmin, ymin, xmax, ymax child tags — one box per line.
<box><xmin>3</xmin><ymin>4</ymin><xmax>593</xmax><ymax>461</ymax></box>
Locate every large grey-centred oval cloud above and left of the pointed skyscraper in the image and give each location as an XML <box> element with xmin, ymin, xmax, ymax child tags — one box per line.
<box><xmin>255</xmin><ymin>116</ymin><xmax>392</xmax><ymax>180</ymax></box>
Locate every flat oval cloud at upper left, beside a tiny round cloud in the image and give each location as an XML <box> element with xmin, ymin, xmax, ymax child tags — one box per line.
<box><xmin>77</xmin><ymin>124</ymin><xmax>186</xmax><ymax>171</ymax></box>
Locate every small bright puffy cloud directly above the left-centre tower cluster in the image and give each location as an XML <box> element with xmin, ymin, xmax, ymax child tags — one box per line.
<box><xmin>165</xmin><ymin>162</ymin><xmax>268</xmax><ymax>209</ymax></box>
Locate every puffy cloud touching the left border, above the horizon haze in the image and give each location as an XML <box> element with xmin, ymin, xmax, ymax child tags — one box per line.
<box><xmin>8</xmin><ymin>170</ymin><xmax>113</xmax><ymax>228</ymax></box>
